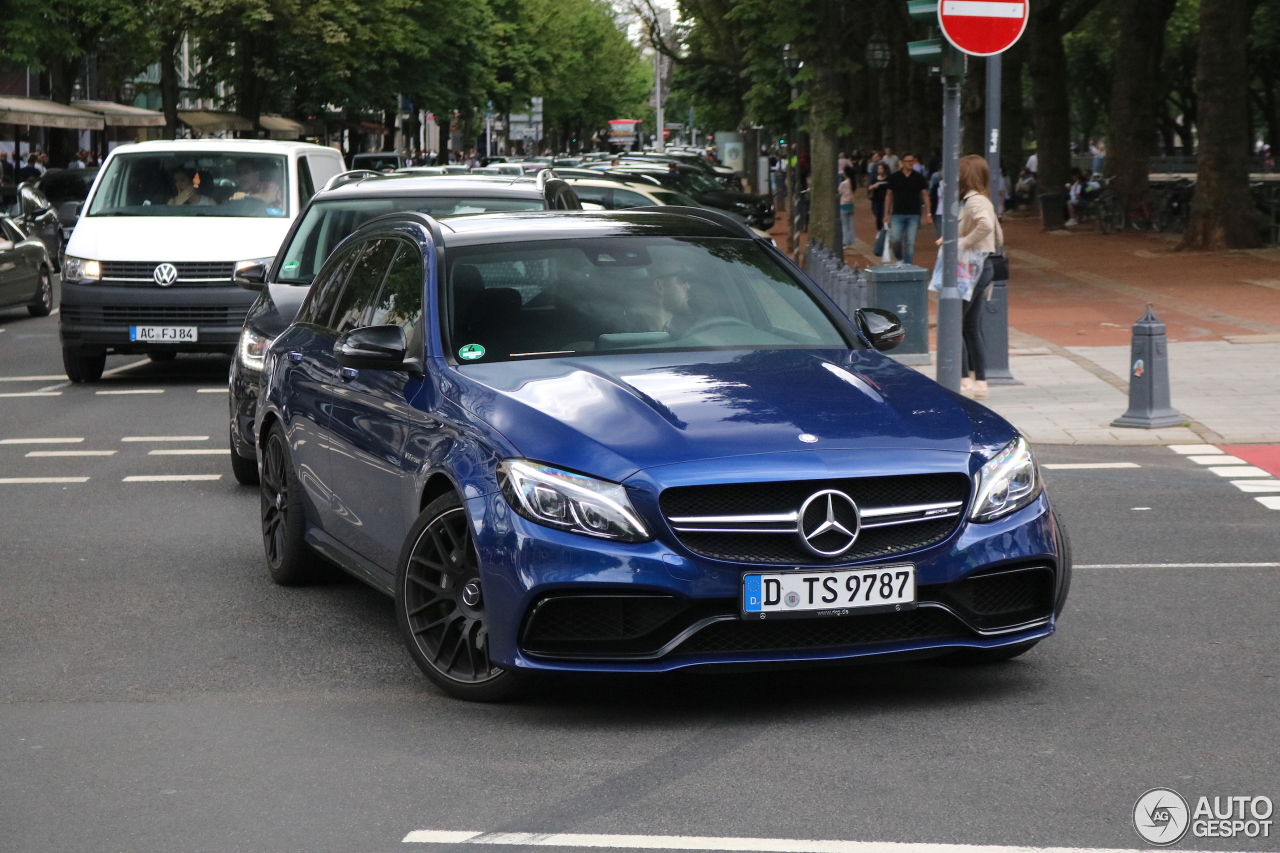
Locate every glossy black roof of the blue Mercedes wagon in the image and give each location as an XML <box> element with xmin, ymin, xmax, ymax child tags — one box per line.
<box><xmin>439</xmin><ymin>207</ymin><xmax>755</xmax><ymax>247</ymax></box>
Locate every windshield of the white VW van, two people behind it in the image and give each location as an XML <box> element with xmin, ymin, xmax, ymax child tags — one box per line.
<box><xmin>88</xmin><ymin>151</ymin><xmax>289</xmax><ymax>216</ymax></box>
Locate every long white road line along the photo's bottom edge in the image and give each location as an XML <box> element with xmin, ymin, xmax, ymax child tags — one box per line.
<box><xmin>402</xmin><ymin>830</ymin><xmax>1233</xmax><ymax>853</ymax></box>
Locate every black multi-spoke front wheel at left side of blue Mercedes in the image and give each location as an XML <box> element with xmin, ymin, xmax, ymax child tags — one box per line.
<box><xmin>396</xmin><ymin>492</ymin><xmax>527</xmax><ymax>702</ymax></box>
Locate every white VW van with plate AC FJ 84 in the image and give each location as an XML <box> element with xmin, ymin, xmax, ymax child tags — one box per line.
<box><xmin>59</xmin><ymin>140</ymin><xmax>344</xmax><ymax>382</ymax></box>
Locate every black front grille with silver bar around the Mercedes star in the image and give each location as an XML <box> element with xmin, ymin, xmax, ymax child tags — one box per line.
<box><xmin>659</xmin><ymin>474</ymin><xmax>969</xmax><ymax>565</ymax></box>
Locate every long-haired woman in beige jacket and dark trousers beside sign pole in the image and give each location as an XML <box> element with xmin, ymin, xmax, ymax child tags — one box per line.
<box><xmin>938</xmin><ymin>154</ymin><xmax>1005</xmax><ymax>400</ymax></box>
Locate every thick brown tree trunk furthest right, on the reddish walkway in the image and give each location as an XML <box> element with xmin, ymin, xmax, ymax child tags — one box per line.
<box><xmin>1179</xmin><ymin>0</ymin><xmax>1262</xmax><ymax>248</ymax></box>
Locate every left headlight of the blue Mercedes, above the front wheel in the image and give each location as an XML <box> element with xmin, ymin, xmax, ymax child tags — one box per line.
<box><xmin>498</xmin><ymin>459</ymin><xmax>652</xmax><ymax>542</ymax></box>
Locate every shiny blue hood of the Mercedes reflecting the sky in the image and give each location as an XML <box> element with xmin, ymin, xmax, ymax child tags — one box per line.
<box><xmin>445</xmin><ymin>350</ymin><xmax>1012</xmax><ymax>480</ymax></box>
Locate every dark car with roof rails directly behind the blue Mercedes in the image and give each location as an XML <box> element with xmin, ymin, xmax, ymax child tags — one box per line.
<box><xmin>229</xmin><ymin>170</ymin><xmax>580</xmax><ymax>484</ymax></box>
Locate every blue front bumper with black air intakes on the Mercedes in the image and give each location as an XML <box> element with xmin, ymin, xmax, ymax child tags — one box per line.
<box><xmin>467</xmin><ymin>494</ymin><xmax>1070</xmax><ymax>672</ymax></box>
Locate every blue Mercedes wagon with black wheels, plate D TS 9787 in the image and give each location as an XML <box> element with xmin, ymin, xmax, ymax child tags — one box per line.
<box><xmin>256</xmin><ymin>211</ymin><xmax>1070</xmax><ymax>701</ymax></box>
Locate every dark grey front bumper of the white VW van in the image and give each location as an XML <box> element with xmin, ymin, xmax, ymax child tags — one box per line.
<box><xmin>59</xmin><ymin>282</ymin><xmax>257</xmax><ymax>353</ymax></box>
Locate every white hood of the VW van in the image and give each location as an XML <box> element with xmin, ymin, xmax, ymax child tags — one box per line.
<box><xmin>67</xmin><ymin>216</ymin><xmax>289</xmax><ymax>261</ymax></box>
